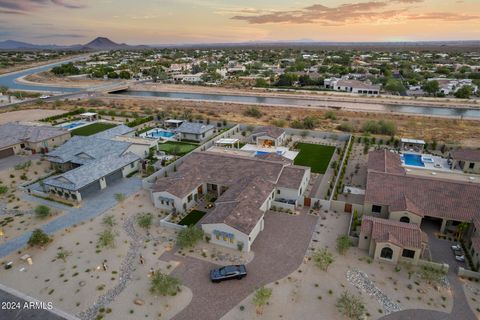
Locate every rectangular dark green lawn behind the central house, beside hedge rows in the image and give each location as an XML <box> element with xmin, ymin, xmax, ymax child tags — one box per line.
<box><xmin>294</xmin><ymin>142</ymin><xmax>335</xmax><ymax>174</ymax></box>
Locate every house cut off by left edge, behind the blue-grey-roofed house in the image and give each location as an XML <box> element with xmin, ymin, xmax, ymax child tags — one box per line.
<box><xmin>0</xmin><ymin>123</ymin><xmax>71</xmax><ymax>158</ymax></box>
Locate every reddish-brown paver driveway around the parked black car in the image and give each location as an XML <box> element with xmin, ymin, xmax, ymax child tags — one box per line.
<box><xmin>162</xmin><ymin>212</ymin><xmax>318</xmax><ymax>320</ymax></box>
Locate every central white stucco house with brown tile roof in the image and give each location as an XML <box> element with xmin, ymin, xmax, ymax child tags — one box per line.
<box><xmin>151</xmin><ymin>152</ymin><xmax>310</xmax><ymax>251</ymax></box>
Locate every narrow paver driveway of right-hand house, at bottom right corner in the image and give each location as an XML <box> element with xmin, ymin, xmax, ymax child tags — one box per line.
<box><xmin>381</xmin><ymin>220</ymin><xmax>477</xmax><ymax>320</ymax></box>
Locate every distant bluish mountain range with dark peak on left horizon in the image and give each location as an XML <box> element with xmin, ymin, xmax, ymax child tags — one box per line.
<box><xmin>0</xmin><ymin>37</ymin><xmax>149</xmax><ymax>51</ymax></box>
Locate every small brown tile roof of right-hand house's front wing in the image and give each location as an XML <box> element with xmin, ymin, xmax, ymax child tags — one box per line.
<box><xmin>361</xmin><ymin>216</ymin><xmax>426</xmax><ymax>248</ymax></box>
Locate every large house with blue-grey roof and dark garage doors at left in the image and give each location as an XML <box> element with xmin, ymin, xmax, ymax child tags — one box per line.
<box><xmin>43</xmin><ymin>126</ymin><xmax>144</xmax><ymax>202</ymax></box>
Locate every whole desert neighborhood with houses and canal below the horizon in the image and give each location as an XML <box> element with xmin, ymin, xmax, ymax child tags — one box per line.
<box><xmin>0</xmin><ymin>39</ymin><xmax>480</xmax><ymax>320</ymax></box>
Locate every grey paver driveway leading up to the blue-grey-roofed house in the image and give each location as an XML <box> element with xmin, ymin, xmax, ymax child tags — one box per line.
<box><xmin>0</xmin><ymin>178</ymin><xmax>142</xmax><ymax>258</ymax></box>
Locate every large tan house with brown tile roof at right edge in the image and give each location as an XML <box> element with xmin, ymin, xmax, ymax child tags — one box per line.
<box><xmin>359</xmin><ymin>150</ymin><xmax>480</xmax><ymax>263</ymax></box>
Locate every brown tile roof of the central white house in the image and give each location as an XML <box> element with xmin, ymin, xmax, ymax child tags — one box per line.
<box><xmin>153</xmin><ymin>152</ymin><xmax>309</xmax><ymax>234</ymax></box>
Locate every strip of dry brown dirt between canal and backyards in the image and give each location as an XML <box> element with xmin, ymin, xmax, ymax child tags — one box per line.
<box><xmin>55</xmin><ymin>96</ymin><xmax>480</xmax><ymax>147</ymax></box>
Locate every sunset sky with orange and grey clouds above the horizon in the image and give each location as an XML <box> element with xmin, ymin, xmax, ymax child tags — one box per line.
<box><xmin>0</xmin><ymin>0</ymin><xmax>480</xmax><ymax>44</ymax></box>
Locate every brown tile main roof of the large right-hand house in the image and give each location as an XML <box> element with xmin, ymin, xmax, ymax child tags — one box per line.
<box><xmin>365</xmin><ymin>150</ymin><xmax>480</xmax><ymax>221</ymax></box>
